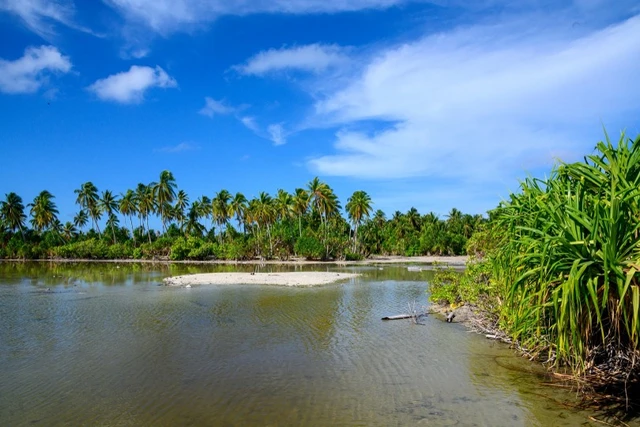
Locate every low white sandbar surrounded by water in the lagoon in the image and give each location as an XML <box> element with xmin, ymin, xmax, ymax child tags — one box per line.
<box><xmin>164</xmin><ymin>271</ymin><xmax>360</xmax><ymax>286</ymax></box>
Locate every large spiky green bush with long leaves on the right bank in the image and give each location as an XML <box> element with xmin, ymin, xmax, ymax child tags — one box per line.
<box><xmin>432</xmin><ymin>135</ymin><xmax>640</xmax><ymax>405</ymax></box>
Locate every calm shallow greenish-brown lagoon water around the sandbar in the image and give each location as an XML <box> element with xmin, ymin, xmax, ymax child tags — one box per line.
<box><xmin>0</xmin><ymin>263</ymin><xmax>608</xmax><ymax>426</ymax></box>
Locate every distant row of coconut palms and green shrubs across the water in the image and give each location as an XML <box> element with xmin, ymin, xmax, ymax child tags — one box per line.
<box><xmin>0</xmin><ymin>175</ymin><xmax>483</xmax><ymax>260</ymax></box>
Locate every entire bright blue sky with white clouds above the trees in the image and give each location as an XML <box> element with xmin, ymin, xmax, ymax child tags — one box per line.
<box><xmin>0</xmin><ymin>0</ymin><xmax>640</xmax><ymax>227</ymax></box>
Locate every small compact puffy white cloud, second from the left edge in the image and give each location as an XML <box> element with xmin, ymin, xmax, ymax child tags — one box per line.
<box><xmin>88</xmin><ymin>65</ymin><xmax>178</xmax><ymax>104</ymax></box>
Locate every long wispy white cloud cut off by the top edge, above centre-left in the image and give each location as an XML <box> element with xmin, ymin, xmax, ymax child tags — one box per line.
<box><xmin>104</xmin><ymin>0</ymin><xmax>407</xmax><ymax>34</ymax></box>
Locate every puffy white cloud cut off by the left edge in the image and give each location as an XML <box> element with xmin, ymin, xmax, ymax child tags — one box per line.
<box><xmin>0</xmin><ymin>46</ymin><xmax>71</xmax><ymax>93</ymax></box>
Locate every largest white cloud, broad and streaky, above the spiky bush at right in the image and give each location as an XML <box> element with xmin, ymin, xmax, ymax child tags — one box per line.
<box><xmin>309</xmin><ymin>17</ymin><xmax>640</xmax><ymax>181</ymax></box>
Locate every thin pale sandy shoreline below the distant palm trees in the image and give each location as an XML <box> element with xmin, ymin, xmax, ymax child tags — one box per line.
<box><xmin>0</xmin><ymin>255</ymin><xmax>468</xmax><ymax>267</ymax></box>
